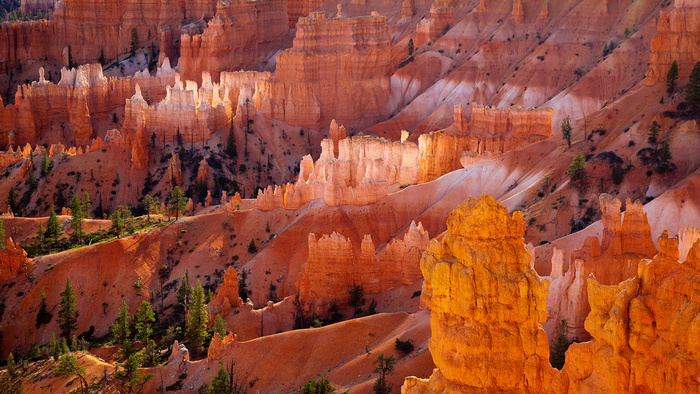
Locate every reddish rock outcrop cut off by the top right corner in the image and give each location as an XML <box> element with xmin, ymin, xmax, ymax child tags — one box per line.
<box><xmin>645</xmin><ymin>0</ymin><xmax>700</xmax><ymax>86</ymax></box>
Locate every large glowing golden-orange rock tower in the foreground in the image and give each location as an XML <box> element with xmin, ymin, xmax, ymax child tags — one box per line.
<box><xmin>402</xmin><ymin>196</ymin><xmax>552</xmax><ymax>393</ymax></box>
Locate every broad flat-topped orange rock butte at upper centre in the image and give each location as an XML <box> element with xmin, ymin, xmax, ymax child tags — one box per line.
<box><xmin>254</xmin><ymin>12</ymin><xmax>391</xmax><ymax>129</ymax></box>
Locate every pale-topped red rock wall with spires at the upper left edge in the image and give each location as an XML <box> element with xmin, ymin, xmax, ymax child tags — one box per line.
<box><xmin>0</xmin><ymin>61</ymin><xmax>175</xmax><ymax>147</ymax></box>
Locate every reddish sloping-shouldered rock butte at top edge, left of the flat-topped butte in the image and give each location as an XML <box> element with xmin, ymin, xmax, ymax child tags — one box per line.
<box><xmin>178</xmin><ymin>0</ymin><xmax>289</xmax><ymax>82</ymax></box>
